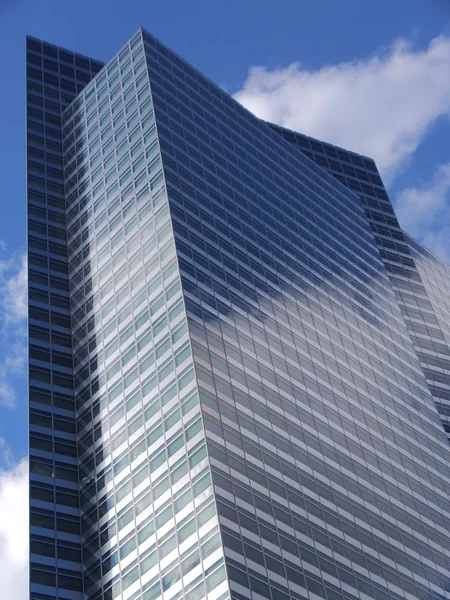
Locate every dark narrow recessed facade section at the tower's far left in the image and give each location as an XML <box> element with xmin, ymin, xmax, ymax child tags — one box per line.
<box><xmin>27</xmin><ymin>38</ymin><xmax>102</xmax><ymax>600</ymax></box>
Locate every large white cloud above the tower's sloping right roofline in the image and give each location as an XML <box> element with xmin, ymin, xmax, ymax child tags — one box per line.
<box><xmin>234</xmin><ymin>36</ymin><xmax>450</xmax><ymax>178</ymax></box>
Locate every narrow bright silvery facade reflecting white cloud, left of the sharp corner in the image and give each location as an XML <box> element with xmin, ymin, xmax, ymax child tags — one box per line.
<box><xmin>62</xmin><ymin>33</ymin><xmax>227</xmax><ymax>600</ymax></box>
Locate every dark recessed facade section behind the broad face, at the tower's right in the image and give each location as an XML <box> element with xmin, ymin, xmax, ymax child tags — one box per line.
<box><xmin>270</xmin><ymin>124</ymin><xmax>450</xmax><ymax>439</ymax></box>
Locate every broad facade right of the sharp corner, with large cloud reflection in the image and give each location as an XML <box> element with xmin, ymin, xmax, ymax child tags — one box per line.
<box><xmin>142</xmin><ymin>29</ymin><xmax>450</xmax><ymax>600</ymax></box>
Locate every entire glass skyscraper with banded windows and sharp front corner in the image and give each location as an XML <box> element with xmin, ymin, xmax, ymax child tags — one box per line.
<box><xmin>27</xmin><ymin>30</ymin><xmax>450</xmax><ymax>600</ymax></box>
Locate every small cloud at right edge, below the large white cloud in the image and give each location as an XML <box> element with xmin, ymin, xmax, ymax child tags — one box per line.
<box><xmin>395</xmin><ymin>162</ymin><xmax>450</xmax><ymax>263</ymax></box>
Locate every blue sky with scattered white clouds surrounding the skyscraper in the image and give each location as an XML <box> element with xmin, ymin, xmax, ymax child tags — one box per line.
<box><xmin>0</xmin><ymin>0</ymin><xmax>450</xmax><ymax>598</ymax></box>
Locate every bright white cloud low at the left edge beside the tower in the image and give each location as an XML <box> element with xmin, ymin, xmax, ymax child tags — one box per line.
<box><xmin>0</xmin><ymin>454</ymin><xmax>28</xmax><ymax>600</ymax></box>
